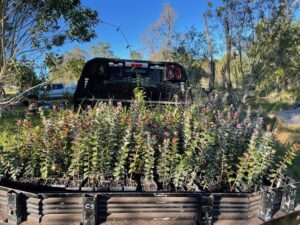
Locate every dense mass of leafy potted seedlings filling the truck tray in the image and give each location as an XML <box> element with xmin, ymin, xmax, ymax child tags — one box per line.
<box><xmin>0</xmin><ymin>90</ymin><xmax>295</xmax><ymax>191</ymax></box>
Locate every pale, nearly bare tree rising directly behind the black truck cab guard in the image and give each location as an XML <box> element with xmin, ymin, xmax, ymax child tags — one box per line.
<box><xmin>143</xmin><ymin>3</ymin><xmax>177</xmax><ymax>61</ymax></box>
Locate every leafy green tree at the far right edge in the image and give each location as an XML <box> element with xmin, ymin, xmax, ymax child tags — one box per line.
<box><xmin>248</xmin><ymin>2</ymin><xmax>300</xmax><ymax>94</ymax></box>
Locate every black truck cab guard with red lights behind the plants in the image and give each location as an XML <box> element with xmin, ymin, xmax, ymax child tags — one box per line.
<box><xmin>74</xmin><ymin>58</ymin><xmax>188</xmax><ymax>108</ymax></box>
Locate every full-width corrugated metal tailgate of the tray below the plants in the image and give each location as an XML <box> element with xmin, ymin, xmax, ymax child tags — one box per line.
<box><xmin>0</xmin><ymin>183</ymin><xmax>292</xmax><ymax>225</ymax></box>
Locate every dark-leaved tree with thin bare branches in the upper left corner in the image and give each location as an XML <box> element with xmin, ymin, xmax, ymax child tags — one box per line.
<box><xmin>0</xmin><ymin>0</ymin><xmax>98</xmax><ymax>88</ymax></box>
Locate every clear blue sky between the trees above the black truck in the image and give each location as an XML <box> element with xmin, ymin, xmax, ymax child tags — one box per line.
<box><xmin>60</xmin><ymin>0</ymin><xmax>219</xmax><ymax>58</ymax></box>
